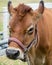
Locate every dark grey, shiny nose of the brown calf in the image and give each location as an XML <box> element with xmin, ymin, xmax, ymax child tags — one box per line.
<box><xmin>6</xmin><ymin>49</ymin><xmax>20</xmax><ymax>59</ymax></box>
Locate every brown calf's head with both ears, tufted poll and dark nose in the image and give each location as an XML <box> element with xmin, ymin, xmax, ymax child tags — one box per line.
<box><xmin>6</xmin><ymin>1</ymin><xmax>44</xmax><ymax>60</ymax></box>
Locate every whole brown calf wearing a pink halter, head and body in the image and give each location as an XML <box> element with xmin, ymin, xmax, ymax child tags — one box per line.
<box><xmin>6</xmin><ymin>1</ymin><xmax>52</xmax><ymax>65</ymax></box>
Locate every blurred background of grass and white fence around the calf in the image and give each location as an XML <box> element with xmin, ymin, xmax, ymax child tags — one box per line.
<box><xmin>0</xmin><ymin>0</ymin><xmax>52</xmax><ymax>65</ymax></box>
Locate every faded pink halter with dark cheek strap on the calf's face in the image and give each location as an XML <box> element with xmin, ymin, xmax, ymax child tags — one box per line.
<box><xmin>8</xmin><ymin>14</ymin><xmax>41</xmax><ymax>53</ymax></box>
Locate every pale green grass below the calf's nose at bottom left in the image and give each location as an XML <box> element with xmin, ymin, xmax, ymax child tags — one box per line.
<box><xmin>0</xmin><ymin>56</ymin><xmax>27</xmax><ymax>65</ymax></box>
